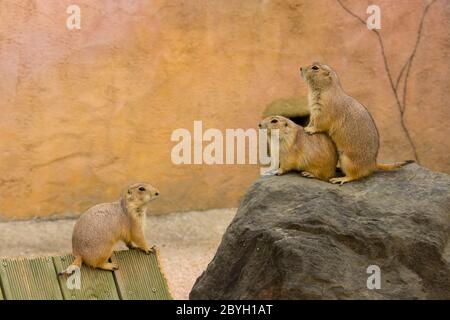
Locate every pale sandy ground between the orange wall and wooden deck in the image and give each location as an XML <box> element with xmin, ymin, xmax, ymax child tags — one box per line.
<box><xmin>0</xmin><ymin>209</ymin><xmax>236</xmax><ymax>299</ymax></box>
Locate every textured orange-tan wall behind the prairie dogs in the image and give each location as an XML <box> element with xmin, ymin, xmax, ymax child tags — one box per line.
<box><xmin>0</xmin><ymin>0</ymin><xmax>450</xmax><ymax>219</ymax></box>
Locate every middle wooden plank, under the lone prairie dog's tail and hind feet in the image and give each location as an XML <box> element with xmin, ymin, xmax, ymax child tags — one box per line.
<box><xmin>53</xmin><ymin>254</ymin><xmax>119</xmax><ymax>300</ymax></box>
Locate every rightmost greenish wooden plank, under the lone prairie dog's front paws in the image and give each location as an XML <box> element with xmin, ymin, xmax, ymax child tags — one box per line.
<box><xmin>112</xmin><ymin>250</ymin><xmax>172</xmax><ymax>300</ymax></box>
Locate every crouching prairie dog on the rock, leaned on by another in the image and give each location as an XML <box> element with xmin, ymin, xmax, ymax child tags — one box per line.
<box><xmin>259</xmin><ymin>116</ymin><xmax>338</xmax><ymax>181</ymax></box>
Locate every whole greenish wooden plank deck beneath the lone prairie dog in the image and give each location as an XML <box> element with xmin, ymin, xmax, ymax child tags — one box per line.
<box><xmin>0</xmin><ymin>250</ymin><xmax>172</xmax><ymax>300</ymax></box>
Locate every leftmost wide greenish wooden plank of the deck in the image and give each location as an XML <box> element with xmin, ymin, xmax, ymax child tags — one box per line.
<box><xmin>0</xmin><ymin>257</ymin><xmax>63</xmax><ymax>300</ymax></box>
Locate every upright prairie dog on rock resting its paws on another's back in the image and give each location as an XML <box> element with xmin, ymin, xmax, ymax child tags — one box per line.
<box><xmin>300</xmin><ymin>62</ymin><xmax>410</xmax><ymax>184</ymax></box>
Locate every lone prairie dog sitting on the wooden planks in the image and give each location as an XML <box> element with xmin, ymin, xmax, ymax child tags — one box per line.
<box><xmin>60</xmin><ymin>183</ymin><xmax>159</xmax><ymax>274</ymax></box>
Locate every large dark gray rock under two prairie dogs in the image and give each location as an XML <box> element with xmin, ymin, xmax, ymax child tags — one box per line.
<box><xmin>190</xmin><ymin>164</ymin><xmax>450</xmax><ymax>299</ymax></box>
